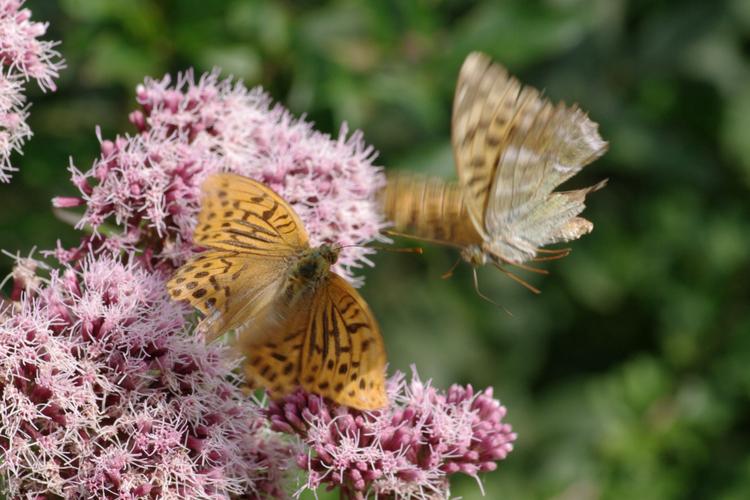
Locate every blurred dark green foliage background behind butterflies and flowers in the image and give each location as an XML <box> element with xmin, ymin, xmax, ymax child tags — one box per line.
<box><xmin>0</xmin><ymin>0</ymin><xmax>750</xmax><ymax>500</ymax></box>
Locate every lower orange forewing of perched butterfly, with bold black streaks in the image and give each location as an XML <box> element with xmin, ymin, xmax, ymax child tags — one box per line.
<box><xmin>300</xmin><ymin>273</ymin><xmax>388</xmax><ymax>410</ymax></box>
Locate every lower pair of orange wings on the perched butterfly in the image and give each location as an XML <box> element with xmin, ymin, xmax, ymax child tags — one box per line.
<box><xmin>238</xmin><ymin>273</ymin><xmax>388</xmax><ymax>410</ymax></box>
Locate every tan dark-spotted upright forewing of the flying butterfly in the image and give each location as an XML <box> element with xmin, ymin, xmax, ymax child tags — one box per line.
<box><xmin>451</xmin><ymin>52</ymin><xmax>521</xmax><ymax>234</ymax></box>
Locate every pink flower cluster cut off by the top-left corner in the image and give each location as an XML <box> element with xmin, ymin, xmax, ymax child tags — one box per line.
<box><xmin>0</xmin><ymin>0</ymin><xmax>64</xmax><ymax>182</ymax></box>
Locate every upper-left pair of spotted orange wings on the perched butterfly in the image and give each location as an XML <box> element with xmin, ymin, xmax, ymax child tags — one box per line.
<box><xmin>167</xmin><ymin>173</ymin><xmax>309</xmax><ymax>341</ymax></box>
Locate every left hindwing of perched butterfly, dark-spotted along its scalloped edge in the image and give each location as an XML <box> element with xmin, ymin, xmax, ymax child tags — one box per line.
<box><xmin>167</xmin><ymin>250</ymin><xmax>286</xmax><ymax>340</ymax></box>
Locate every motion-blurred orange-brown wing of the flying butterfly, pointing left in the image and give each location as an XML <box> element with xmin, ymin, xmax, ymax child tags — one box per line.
<box><xmin>380</xmin><ymin>172</ymin><xmax>482</xmax><ymax>248</ymax></box>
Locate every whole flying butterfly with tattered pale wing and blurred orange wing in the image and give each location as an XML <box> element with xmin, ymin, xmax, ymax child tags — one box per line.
<box><xmin>381</xmin><ymin>52</ymin><xmax>607</xmax><ymax>300</ymax></box>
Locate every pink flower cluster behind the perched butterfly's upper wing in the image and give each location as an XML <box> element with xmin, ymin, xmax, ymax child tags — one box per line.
<box><xmin>54</xmin><ymin>72</ymin><xmax>385</xmax><ymax>282</ymax></box>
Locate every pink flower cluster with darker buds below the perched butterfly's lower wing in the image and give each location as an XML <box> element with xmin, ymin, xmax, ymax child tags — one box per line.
<box><xmin>268</xmin><ymin>372</ymin><xmax>516</xmax><ymax>498</ymax></box>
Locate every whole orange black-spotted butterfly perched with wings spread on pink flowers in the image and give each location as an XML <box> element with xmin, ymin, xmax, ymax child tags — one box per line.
<box><xmin>167</xmin><ymin>173</ymin><xmax>388</xmax><ymax>410</ymax></box>
